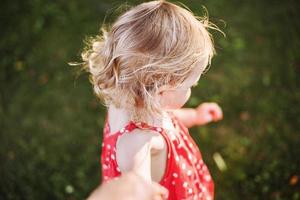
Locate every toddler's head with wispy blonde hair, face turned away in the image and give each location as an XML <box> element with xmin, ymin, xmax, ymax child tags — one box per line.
<box><xmin>82</xmin><ymin>1</ymin><xmax>215</xmax><ymax>120</ymax></box>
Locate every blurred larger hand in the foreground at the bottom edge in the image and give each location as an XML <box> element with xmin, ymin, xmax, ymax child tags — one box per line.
<box><xmin>87</xmin><ymin>172</ymin><xmax>168</xmax><ymax>200</ymax></box>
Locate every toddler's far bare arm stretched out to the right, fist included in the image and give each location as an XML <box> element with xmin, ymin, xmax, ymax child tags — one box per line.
<box><xmin>172</xmin><ymin>103</ymin><xmax>223</xmax><ymax>128</ymax></box>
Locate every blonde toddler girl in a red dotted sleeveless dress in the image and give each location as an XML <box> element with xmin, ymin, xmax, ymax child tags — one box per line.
<box><xmin>82</xmin><ymin>1</ymin><xmax>222</xmax><ymax>200</ymax></box>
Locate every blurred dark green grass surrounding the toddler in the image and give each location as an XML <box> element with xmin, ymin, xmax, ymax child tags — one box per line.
<box><xmin>0</xmin><ymin>0</ymin><xmax>300</xmax><ymax>200</ymax></box>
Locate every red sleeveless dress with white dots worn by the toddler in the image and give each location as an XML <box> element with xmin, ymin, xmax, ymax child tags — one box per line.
<box><xmin>101</xmin><ymin>113</ymin><xmax>214</xmax><ymax>200</ymax></box>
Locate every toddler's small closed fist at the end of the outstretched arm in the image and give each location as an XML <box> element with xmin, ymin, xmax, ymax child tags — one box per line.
<box><xmin>195</xmin><ymin>102</ymin><xmax>223</xmax><ymax>125</ymax></box>
